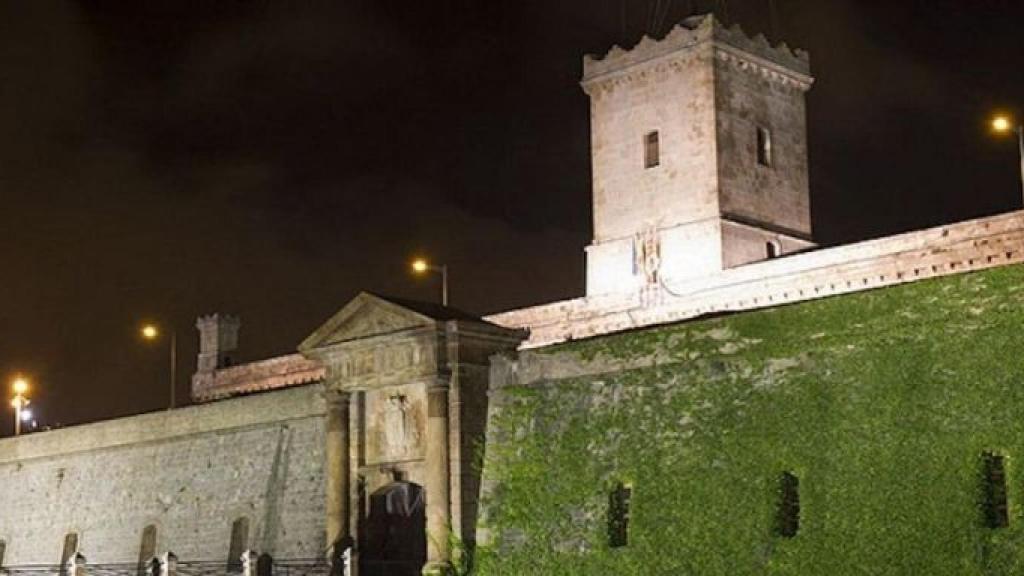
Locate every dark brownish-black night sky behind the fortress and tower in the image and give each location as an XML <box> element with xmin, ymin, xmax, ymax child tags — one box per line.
<box><xmin>0</xmin><ymin>0</ymin><xmax>1024</xmax><ymax>434</ymax></box>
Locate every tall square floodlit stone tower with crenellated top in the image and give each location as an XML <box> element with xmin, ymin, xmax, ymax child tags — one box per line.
<box><xmin>582</xmin><ymin>15</ymin><xmax>813</xmax><ymax>295</ymax></box>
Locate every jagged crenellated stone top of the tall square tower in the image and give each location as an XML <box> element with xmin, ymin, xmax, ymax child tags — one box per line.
<box><xmin>583</xmin><ymin>14</ymin><xmax>811</xmax><ymax>86</ymax></box>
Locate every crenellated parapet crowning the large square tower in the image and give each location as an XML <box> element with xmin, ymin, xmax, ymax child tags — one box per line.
<box><xmin>582</xmin><ymin>14</ymin><xmax>813</xmax><ymax>93</ymax></box>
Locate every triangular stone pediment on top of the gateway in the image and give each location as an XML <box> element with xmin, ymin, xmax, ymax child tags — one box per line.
<box><xmin>299</xmin><ymin>292</ymin><xmax>436</xmax><ymax>354</ymax></box>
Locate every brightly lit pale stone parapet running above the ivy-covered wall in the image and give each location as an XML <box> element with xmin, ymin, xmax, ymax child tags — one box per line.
<box><xmin>485</xmin><ymin>211</ymin><xmax>1024</xmax><ymax>348</ymax></box>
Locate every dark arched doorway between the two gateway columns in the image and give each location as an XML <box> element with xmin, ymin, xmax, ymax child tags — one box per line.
<box><xmin>359</xmin><ymin>482</ymin><xmax>427</xmax><ymax>576</ymax></box>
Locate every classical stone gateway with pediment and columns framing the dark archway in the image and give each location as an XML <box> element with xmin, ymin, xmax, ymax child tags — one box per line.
<box><xmin>299</xmin><ymin>293</ymin><xmax>524</xmax><ymax>570</ymax></box>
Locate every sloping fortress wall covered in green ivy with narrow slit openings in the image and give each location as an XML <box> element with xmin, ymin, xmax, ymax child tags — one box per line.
<box><xmin>474</xmin><ymin>266</ymin><xmax>1024</xmax><ymax>576</ymax></box>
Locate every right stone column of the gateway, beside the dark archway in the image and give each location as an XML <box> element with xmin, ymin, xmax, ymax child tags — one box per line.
<box><xmin>423</xmin><ymin>377</ymin><xmax>452</xmax><ymax>575</ymax></box>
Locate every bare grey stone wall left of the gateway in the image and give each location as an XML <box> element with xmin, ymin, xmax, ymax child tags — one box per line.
<box><xmin>0</xmin><ymin>385</ymin><xmax>325</xmax><ymax>566</ymax></box>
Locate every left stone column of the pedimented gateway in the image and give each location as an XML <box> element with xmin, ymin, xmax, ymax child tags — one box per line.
<box><xmin>325</xmin><ymin>384</ymin><xmax>352</xmax><ymax>560</ymax></box>
